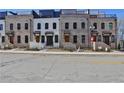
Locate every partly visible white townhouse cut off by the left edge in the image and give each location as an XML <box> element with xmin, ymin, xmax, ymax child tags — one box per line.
<box><xmin>0</xmin><ymin>19</ymin><xmax>5</xmax><ymax>48</ymax></box>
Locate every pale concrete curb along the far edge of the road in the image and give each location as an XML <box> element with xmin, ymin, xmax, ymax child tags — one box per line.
<box><xmin>0</xmin><ymin>51</ymin><xmax>124</xmax><ymax>56</ymax></box>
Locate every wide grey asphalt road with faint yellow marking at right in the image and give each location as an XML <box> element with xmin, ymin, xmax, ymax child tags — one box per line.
<box><xmin>0</xmin><ymin>53</ymin><xmax>124</xmax><ymax>83</ymax></box>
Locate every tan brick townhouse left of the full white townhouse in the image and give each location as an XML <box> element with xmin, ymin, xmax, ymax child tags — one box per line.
<box><xmin>5</xmin><ymin>15</ymin><xmax>33</xmax><ymax>48</ymax></box>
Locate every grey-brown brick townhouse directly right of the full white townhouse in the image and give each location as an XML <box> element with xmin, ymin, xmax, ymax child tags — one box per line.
<box><xmin>60</xmin><ymin>10</ymin><xmax>89</xmax><ymax>48</ymax></box>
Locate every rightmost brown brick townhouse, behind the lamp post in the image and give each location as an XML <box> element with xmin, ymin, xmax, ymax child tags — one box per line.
<box><xmin>89</xmin><ymin>14</ymin><xmax>117</xmax><ymax>48</ymax></box>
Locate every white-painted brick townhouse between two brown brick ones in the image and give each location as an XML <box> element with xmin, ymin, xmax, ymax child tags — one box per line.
<box><xmin>30</xmin><ymin>18</ymin><xmax>60</xmax><ymax>49</ymax></box>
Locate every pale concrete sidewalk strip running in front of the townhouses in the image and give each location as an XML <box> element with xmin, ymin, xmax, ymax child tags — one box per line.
<box><xmin>0</xmin><ymin>49</ymin><xmax>124</xmax><ymax>56</ymax></box>
